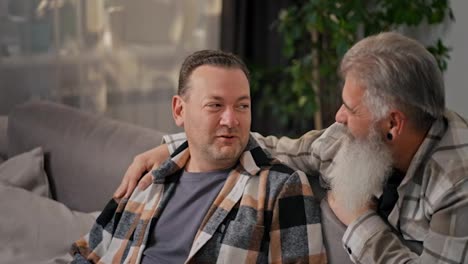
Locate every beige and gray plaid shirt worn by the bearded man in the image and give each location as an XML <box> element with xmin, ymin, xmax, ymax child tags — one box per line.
<box><xmin>256</xmin><ymin>111</ymin><xmax>468</xmax><ymax>263</ymax></box>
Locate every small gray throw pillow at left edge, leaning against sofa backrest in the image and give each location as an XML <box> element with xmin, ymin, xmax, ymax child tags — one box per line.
<box><xmin>0</xmin><ymin>147</ymin><xmax>50</xmax><ymax>197</ymax></box>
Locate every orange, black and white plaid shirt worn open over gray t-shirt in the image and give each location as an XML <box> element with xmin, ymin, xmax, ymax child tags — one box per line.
<box><xmin>71</xmin><ymin>137</ymin><xmax>326</xmax><ymax>263</ymax></box>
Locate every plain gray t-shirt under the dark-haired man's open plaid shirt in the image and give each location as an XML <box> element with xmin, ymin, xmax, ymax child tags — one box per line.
<box><xmin>141</xmin><ymin>169</ymin><xmax>231</xmax><ymax>264</ymax></box>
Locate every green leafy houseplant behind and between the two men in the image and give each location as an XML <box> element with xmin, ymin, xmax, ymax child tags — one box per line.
<box><xmin>252</xmin><ymin>0</ymin><xmax>454</xmax><ymax>136</ymax></box>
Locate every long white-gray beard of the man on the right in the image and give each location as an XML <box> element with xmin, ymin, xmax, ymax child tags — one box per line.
<box><xmin>329</xmin><ymin>129</ymin><xmax>392</xmax><ymax>212</ymax></box>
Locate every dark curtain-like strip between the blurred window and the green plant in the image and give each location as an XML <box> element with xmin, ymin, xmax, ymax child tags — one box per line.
<box><xmin>221</xmin><ymin>0</ymin><xmax>294</xmax><ymax>134</ymax></box>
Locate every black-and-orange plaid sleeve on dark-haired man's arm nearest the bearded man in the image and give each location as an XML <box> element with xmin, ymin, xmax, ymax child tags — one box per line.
<box><xmin>269</xmin><ymin>171</ymin><xmax>327</xmax><ymax>263</ymax></box>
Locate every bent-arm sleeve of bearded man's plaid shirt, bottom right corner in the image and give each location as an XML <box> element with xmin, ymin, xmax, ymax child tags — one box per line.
<box><xmin>342</xmin><ymin>179</ymin><xmax>468</xmax><ymax>263</ymax></box>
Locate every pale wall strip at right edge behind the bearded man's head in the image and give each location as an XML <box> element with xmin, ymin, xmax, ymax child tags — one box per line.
<box><xmin>444</xmin><ymin>0</ymin><xmax>468</xmax><ymax>118</ymax></box>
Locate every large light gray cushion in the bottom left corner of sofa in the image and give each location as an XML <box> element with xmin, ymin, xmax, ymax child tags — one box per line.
<box><xmin>0</xmin><ymin>184</ymin><xmax>96</xmax><ymax>264</ymax></box>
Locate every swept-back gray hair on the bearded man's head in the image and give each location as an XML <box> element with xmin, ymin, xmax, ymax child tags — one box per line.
<box><xmin>339</xmin><ymin>32</ymin><xmax>445</xmax><ymax>128</ymax></box>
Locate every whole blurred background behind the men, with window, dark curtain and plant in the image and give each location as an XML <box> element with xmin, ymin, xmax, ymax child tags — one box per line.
<box><xmin>0</xmin><ymin>0</ymin><xmax>468</xmax><ymax>136</ymax></box>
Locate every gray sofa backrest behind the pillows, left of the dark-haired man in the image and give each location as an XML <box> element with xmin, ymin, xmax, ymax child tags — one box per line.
<box><xmin>8</xmin><ymin>101</ymin><xmax>163</xmax><ymax>212</ymax></box>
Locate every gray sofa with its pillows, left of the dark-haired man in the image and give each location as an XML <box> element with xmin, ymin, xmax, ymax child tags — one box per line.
<box><xmin>0</xmin><ymin>101</ymin><xmax>163</xmax><ymax>263</ymax></box>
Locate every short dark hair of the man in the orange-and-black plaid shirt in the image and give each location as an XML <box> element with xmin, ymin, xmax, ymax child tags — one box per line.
<box><xmin>177</xmin><ymin>50</ymin><xmax>249</xmax><ymax>96</ymax></box>
